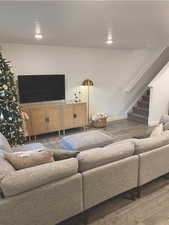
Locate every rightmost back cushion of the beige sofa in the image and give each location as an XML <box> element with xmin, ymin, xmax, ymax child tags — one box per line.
<box><xmin>133</xmin><ymin>131</ymin><xmax>169</xmax><ymax>154</ymax></box>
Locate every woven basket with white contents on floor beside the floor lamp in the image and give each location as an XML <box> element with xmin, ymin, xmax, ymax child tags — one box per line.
<box><xmin>92</xmin><ymin>113</ymin><xmax>108</xmax><ymax>128</ymax></box>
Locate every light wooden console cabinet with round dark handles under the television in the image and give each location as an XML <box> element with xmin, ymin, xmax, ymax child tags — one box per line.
<box><xmin>22</xmin><ymin>102</ymin><xmax>87</xmax><ymax>136</ymax></box>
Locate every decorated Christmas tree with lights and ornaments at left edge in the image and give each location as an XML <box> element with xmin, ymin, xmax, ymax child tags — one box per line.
<box><xmin>0</xmin><ymin>53</ymin><xmax>25</xmax><ymax>146</ymax></box>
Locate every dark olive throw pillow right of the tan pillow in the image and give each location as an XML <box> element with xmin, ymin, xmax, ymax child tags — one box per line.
<box><xmin>51</xmin><ymin>149</ymin><xmax>80</xmax><ymax>161</ymax></box>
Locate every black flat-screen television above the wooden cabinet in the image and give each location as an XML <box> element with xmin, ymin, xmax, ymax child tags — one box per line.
<box><xmin>18</xmin><ymin>75</ymin><xmax>65</xmax><ymax>103</ymax></box>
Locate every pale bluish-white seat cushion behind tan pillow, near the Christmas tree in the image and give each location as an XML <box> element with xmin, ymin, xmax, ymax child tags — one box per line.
<box><xmin>12</xmin><ymin>143</ymin><xmax>46</xmax><ymax>152</ymax></box>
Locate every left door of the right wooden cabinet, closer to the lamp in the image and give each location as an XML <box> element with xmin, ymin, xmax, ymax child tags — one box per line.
<box><xmin>62</xmin><ymin>104</ymin><xmax>74</xmax><ymax>129</ymax></box>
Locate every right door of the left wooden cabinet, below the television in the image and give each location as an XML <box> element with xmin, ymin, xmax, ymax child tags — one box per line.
<box><xmin>46</xmin><ymin>106</ymin><xmax>62</xmax><ymax>132</ymax></box>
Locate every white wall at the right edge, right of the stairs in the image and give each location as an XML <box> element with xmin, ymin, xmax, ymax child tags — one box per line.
<box><xmin>148</xmin><ymin>63</ymin><xmax>169</xmax><ymax>126</ymax></box>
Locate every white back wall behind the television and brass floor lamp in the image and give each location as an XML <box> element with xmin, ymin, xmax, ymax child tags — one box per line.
<box><xmin>1</xmin><ymin>44</ymin><xmax>157</xmax><ymax>119</ymax></box>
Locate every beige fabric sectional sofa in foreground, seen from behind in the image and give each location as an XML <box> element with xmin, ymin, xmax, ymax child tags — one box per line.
<box><xmin>0</xmin><ymin>132</ymin><xmax>169</xmax><ymax>225</ymax></box>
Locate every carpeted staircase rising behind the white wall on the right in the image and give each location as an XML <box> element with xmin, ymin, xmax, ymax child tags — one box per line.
<box><xmin>128</xmin><ymin>89</ymin><xmax>150</xmax><ymax>124</ymax></box>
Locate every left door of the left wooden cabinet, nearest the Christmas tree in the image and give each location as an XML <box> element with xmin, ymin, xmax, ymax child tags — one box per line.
<box><xmin>31</xmin><ymin>107</ymin><xmax>47</xmax><ymax>135</ymax></box>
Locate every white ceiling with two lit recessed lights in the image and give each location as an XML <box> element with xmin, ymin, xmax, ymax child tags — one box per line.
<box><xmin>0</xmin><ymin>1</ymin><xmax>169</xmax><ymax>48</ymax></box>
